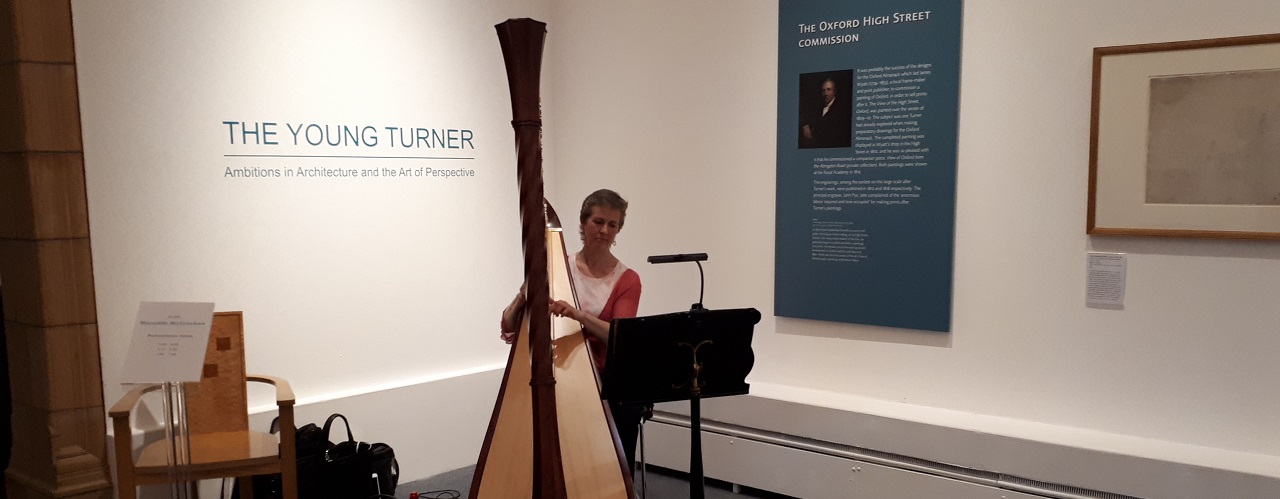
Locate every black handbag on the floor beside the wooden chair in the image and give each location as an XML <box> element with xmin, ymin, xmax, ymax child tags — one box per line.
<box><xmin>320</xmin><ymin>415</ymin><xmax>399</xmax><ymax>499</ymax></box>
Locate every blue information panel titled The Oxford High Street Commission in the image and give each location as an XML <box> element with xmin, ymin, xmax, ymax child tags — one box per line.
<box><xmin>774</xmin><ymin>0</ymin><xmax>963</xmax><ymax>331</ymax></box>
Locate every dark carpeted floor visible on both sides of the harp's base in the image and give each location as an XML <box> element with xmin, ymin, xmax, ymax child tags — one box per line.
<box><xmin>396</xmin><ymin>466</ymin><xmax>787</xmax><ymax>499</ymax></box>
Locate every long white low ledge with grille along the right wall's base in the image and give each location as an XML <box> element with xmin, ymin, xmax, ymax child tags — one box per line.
<box><xmin>645</xmin><ymin>388</ymin><xmax>1280</xmax><ymax>499</ymax></box>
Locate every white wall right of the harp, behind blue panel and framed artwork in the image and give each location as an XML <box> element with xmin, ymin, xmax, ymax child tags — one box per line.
<box><xmin>550</xmin><ymin>0</ymin><xmax>1280</xmax><ymax>478</ymax></box>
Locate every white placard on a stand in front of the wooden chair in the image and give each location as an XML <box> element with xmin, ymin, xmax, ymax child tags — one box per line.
<box><xmin>120</xmin><ymin>302</ymin><xmax>214</xmax><ymax>384</ymax></box>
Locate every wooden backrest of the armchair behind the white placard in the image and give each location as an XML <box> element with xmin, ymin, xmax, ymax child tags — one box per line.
<box><xmin>187</xmin><ymin>312</ymin><xmax>248</xmax><ymax>435</ymax></box>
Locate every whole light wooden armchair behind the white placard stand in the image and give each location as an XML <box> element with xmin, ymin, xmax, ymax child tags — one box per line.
<box><xmin>109</xmin><ymin>312</ymin><xmax>298</xmax><ymax>499</ymax></box>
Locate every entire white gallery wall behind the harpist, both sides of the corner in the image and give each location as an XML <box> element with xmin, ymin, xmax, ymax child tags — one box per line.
<box><xmin>73</xmin><ymin>0</ymin><xmax>1280</xmax><ymax>486</ymax></box>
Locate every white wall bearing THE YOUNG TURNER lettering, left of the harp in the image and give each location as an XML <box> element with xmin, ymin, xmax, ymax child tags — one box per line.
<box><xmin>73</xmin><ymin>0</ymin><xmax>550</xmax><ymax>480</ymax></box>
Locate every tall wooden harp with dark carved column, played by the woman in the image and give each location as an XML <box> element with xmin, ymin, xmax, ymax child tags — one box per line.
<box><xmin>470</xmin><ymin>19</ymin><xmax>632</xmax><ymax>499</ymax></box>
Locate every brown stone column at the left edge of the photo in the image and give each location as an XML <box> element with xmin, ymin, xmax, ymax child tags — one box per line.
<box><xmin>0</xmin><ymin>0</ymin><xmax>111</xmax><ymax>499</ymax></box>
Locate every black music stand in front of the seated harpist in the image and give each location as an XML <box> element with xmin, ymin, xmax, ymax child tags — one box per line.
<box><xmin>603</xmin><ymin>308</ymin><xmax>760</xmax><ymax>499</ymax></box>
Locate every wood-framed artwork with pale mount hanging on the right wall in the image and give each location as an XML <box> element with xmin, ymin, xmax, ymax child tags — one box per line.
<box><xmin>1087</xmin><ymin>35</ymin><xmax>1280</xmax><ymax>239</ymax></box>
